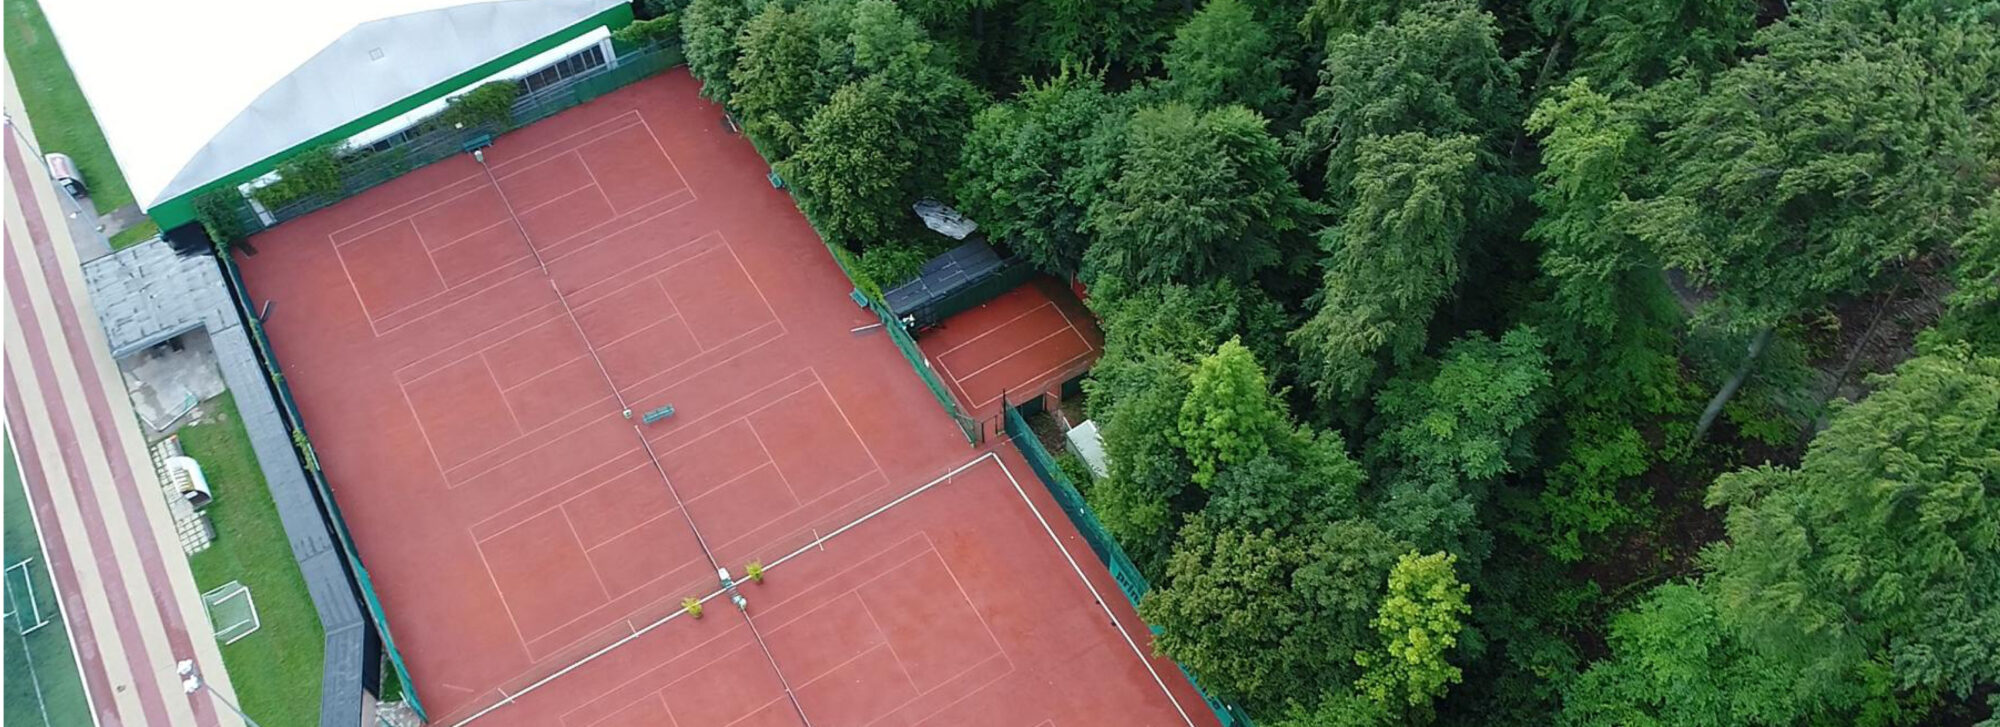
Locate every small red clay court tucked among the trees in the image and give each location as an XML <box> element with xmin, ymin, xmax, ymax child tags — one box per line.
<box><xmin>916</xmin><ymin>278</ymin><xmax>1104</xmax><ymax>419</ymax></box>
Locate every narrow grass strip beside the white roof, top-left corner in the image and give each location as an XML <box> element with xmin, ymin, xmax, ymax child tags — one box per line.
<box><xmin>6</xmin><ymin>0</ymin><xmax>160</xmax><ymax>248</ymax></box>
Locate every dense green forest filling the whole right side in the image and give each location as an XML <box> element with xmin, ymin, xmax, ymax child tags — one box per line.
<box><xmin>636</xmin><ymin>0</ymin><xmax>2000</xmax><ymax>727</ymax></box>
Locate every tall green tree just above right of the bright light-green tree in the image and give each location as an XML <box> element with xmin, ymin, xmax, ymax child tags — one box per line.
<box><xmin>1290</xmin><ymin>132</ymin><xmax>1478</xmax><ymax>403</ymax></box>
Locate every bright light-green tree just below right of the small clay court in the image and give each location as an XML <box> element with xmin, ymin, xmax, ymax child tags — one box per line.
<box><xmin>1180</xmin><ymin>338</ymin><xmax>1292</xmax><ymax>487</ymax></box>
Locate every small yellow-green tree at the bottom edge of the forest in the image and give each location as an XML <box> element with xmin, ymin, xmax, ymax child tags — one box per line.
<box><xmin>1354</xmin><ymin>551</ymin><xmax>1472</xmax><ymax>715</ymax></box>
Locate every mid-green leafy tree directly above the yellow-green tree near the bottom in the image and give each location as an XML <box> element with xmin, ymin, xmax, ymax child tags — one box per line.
<box><xmin>1368</xmin><ymin>328</ymin><xmax>1548</xmax><ymax>571</ymax></box>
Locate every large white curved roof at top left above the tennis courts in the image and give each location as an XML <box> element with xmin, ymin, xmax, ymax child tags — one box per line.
<box><xmin>42</xmin><ymin>0</ymin><xmax>624</xmax><ymax>208</ymax></box>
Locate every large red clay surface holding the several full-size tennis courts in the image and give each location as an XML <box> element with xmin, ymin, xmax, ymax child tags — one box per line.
<box><xmin>236</xmin><ymin>70</ymin><xmax>1214</xmax><ymax>727</ymax></box>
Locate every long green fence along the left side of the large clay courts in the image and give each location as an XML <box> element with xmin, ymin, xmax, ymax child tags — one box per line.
<box><xmin>216</xmin><ymin>252</ymin><xmax>430</xmax><ymax>721</ymax></box>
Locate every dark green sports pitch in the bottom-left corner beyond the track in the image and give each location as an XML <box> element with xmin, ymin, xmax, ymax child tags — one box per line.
<box><xmin>0</xmin><ymin>441</ymin><xmax>92</xmax><ymax>727</ymax></box>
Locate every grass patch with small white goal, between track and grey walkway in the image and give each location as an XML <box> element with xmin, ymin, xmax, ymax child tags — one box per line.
<box><xmin>180</xmin><ymin>393</ymin><xmax>326</xmax><ymax>725</ymax></box>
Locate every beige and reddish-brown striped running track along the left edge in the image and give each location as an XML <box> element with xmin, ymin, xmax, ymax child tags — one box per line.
<box><xmin>0</xmin><ymin>63</ymin><xmax>240</xmax><ymax>727</ymax></box>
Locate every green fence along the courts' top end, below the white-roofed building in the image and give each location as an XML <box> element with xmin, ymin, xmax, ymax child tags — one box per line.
<box><xmin>207</xmin><ymin>46</ymin><xmax>682</xmax><ymax>234</ymax></box>
